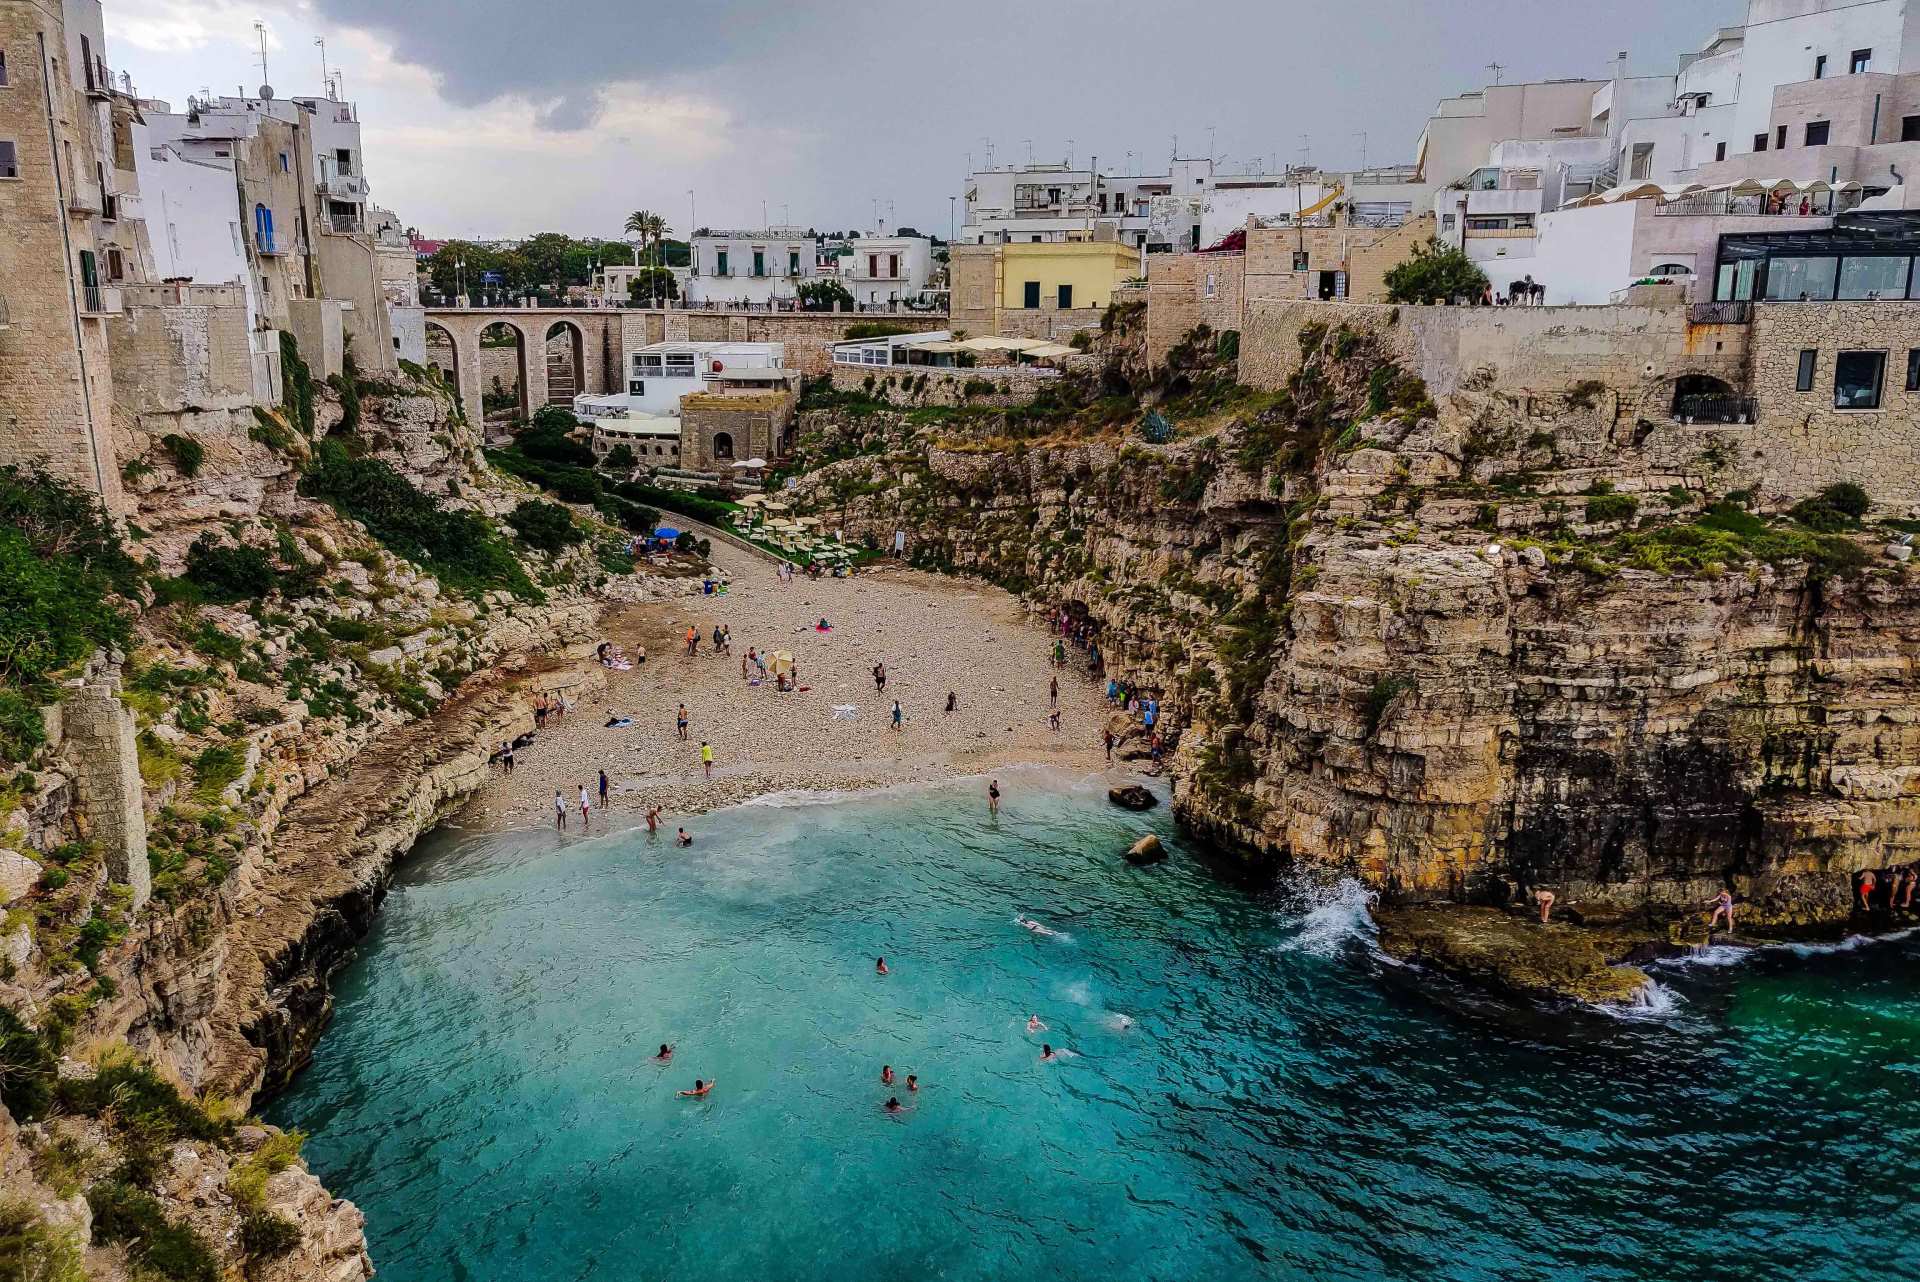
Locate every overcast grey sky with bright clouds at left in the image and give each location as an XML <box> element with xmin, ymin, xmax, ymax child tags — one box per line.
<box><xmin>106</xmin><ymin>0</ymin><xmax>1745</xmax><ymax>238</ymax></box>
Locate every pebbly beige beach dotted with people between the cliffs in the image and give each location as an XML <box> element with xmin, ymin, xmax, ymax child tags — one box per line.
<box><xmin>459</xmin><ymin>543</ymin><xmax>1135</xmax><ymax>831</ymax></box>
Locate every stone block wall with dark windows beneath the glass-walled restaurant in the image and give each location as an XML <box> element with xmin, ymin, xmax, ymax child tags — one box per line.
<box><xmin>1751</xmin><ymin>301</ymin><xmax>1920</xmax><ymax>514</ymax></box>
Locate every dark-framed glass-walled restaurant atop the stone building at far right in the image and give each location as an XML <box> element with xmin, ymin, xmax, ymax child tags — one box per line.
<box><xmin>1713</xmin><ymin>211</ymin><xmax>1920</xmax><ymax>303</ymax></box>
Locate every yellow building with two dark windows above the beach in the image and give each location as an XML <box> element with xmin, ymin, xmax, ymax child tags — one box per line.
<box><xmin>950</xmin><ymin>240</ymin><xmax>1140</xmax><ymax>340</ymax></box>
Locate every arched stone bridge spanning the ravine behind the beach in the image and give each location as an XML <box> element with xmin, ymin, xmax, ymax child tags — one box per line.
<box><xmin>426</xmin><ymin>307</ymin><xmax>948</xmax><ymax>415</ymax></box>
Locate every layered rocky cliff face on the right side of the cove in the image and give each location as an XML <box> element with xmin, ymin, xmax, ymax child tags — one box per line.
<box><xmin>783</xmin><ymin>318</ymin><xmax>1920</xmax><ymax>951</ymax></box>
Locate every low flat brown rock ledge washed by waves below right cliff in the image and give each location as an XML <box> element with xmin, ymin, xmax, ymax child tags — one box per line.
<box><xmin>1375</xmin><ymin>904</ymin><xmax>1653</xmax><ymax>1006</ymax></box>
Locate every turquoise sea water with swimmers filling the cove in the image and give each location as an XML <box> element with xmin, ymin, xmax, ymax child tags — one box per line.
<box><xmin>269</xmin><ymin>775</ymin><xmax>1920</xmax><ymax>1282</ymax></box>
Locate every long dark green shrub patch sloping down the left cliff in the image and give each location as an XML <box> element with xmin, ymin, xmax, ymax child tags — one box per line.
<box><xmin>300</xmin><ymin>441</ymin><xmax>538</xmax><ymax>597</ymax></box>
